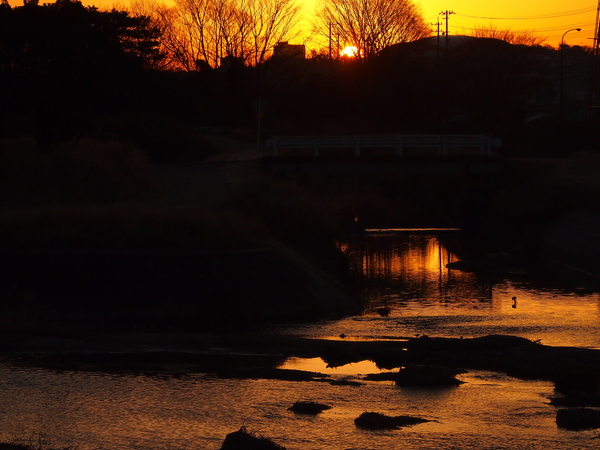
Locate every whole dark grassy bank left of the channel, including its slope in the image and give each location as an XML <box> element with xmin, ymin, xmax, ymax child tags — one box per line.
<box><xmin>0</xmin><ymin>133</ymin><xmax>360</xmax><ymax>342</ymax></box>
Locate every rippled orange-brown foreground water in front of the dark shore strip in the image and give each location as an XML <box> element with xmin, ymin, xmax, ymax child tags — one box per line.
<box><xmin>0</xmin><ymin>369</ymin><xmax>597</xmax><ymax>450</ymax></box>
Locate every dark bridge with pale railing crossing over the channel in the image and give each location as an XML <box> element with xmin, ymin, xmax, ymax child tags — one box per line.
<box><xmin>262</xmin><ymin>134</ymin><xmax>505</xmax><ymax>174</ymax></box>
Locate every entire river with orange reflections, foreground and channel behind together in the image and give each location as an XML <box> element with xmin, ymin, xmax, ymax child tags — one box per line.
<box><xmin>0</xmin><ymin>234</ymin><xmax>600</xmax><ymax>450</ymax></box>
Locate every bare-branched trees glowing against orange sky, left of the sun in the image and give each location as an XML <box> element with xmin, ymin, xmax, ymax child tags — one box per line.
<box><xmin>131</xmin><ymin>0</ymin><xmax>300</xmax><ymax>71</ymax></box>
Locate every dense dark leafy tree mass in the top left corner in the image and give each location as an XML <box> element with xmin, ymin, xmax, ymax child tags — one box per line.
<box><xmin>0</xmin><ymin>0</ymin><xmax>161</xmax><ymax>141</ymax></box>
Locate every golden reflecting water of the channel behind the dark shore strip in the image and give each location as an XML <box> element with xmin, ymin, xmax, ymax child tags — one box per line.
<box><xmin>330</xmin><ymin>234</ymin><xmax>600</xmax><ymax>348</ymax></box>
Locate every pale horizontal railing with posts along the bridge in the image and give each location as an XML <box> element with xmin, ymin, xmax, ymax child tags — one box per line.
<box><xmin>267</xmin><ymin>134</ymin><xmax>500</xmax><ymax>157</ymax></box>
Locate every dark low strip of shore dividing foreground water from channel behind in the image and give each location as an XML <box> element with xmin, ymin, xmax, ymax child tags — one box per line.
<box><xmin>2</xmin><ymin>333</ymin><xmax>600</xmax><ymax>398</ymax></box>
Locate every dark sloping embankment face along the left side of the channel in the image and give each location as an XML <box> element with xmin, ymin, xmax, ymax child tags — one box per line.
<box><xmin>1</xmin><ymin>243</ymin><xmax>360</xmax><ymax>330</ymax></box>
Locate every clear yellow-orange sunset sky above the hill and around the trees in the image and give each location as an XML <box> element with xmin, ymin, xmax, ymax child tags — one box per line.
<box><xmin>9</xmin><ymin>0</ymin><xmax>598</xmax><ymax>46</ymax></box>
